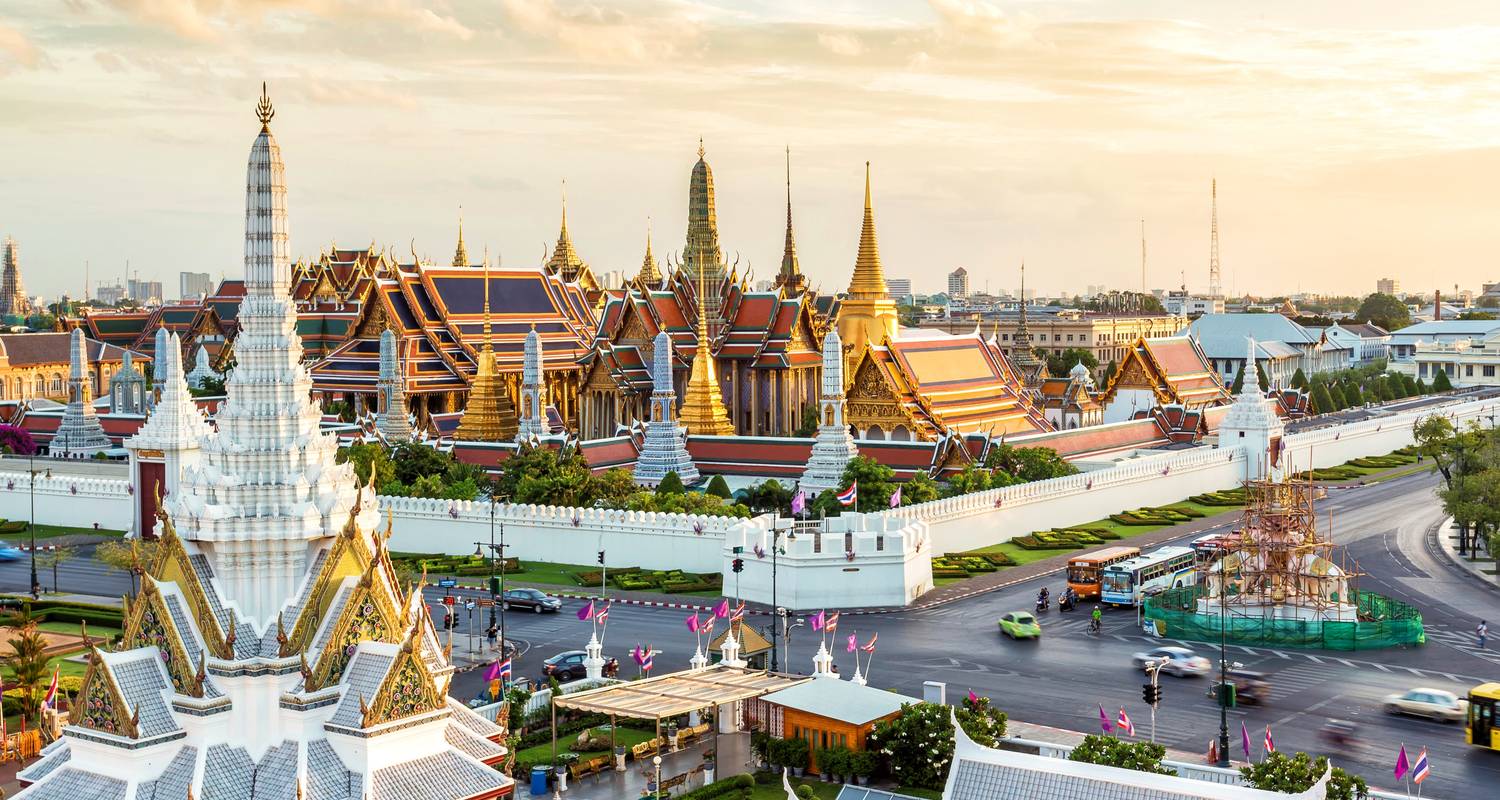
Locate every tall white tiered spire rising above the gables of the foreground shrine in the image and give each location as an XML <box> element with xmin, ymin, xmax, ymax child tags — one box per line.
<box><xmin>165</xmin><ymin>85</ymin><xmax>380</xmax><ymax>624</ymax></box>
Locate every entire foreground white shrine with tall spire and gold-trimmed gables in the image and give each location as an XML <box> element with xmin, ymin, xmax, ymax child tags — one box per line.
<box><xmin>17</xmin><ymin>85</ymin><xmax>513</xmax><ymax>800</ymax></box>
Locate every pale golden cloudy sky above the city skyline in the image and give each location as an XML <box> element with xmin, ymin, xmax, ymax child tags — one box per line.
<box><xmin>0</xmin><ymin>0</ymin><xmax>1500</xmax><ymax>303</ymax></box>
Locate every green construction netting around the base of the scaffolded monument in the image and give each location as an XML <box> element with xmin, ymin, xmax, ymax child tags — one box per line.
<box><xmin>1145</xmin><ymin>587</ymin><xmax>1427</xmax><ymax>650</ymax></box>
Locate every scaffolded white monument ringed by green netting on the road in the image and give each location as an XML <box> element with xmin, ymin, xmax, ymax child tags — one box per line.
<box><xmin>1145</xmin><ymin>479</ymin><xmax>1425</xmax><ymax>650</ymax></box>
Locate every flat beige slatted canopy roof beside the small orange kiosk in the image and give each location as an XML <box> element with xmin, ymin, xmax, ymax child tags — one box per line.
<box><xmin>552</xmin><ymin>663</ymin><xmax>813</xmax><ymax>719</ymax></box>
